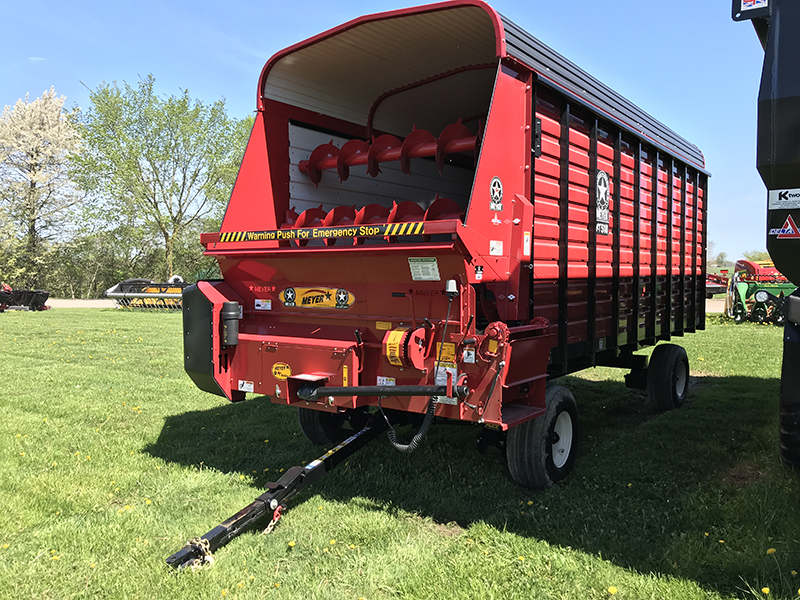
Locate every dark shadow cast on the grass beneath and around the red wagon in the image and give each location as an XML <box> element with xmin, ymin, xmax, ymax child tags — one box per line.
<box><xmin>147</xmin><ymin>376</ymin><xmax>800</xmax><ymax>597</ymax></box>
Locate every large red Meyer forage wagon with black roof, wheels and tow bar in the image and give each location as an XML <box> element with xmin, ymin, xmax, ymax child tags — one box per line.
<box><xmin>169</xmin><ymin>0</ymin><xmax>707</xmax><ymax>565</ymax></box>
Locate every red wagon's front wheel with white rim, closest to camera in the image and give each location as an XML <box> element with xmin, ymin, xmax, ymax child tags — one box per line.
<box><xmin>506</xmin><ymin>385</ymin><xmax>578</xmax><ymax>490</ymax></box>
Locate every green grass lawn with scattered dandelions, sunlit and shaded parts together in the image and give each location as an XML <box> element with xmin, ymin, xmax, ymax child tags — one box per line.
<box><xmin>0</xmin><ymin>309</ymin><xmax>800</xmax><ymax>600</ymax></box>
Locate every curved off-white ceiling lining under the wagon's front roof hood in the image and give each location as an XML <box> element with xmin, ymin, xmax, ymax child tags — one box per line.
<box><xmin>263</xmin><ymin>6</ymin><xmax>496</xmax><ymax>125</ymax></box>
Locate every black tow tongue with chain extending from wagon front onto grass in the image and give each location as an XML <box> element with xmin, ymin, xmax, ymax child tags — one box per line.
<box><xmin>167</xmin><ymin>416</ymin><xmax>387</xmax><ymax>569</ymax></box>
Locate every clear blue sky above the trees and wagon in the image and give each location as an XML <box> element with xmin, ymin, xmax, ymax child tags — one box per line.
<box><xmin>0</xmin><ymin>0</ymin><xmax>766</xmax><ymax>259</ymax></box>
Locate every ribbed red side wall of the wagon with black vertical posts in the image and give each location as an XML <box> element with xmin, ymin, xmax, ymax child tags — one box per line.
<box><xmin>532</xmin><ymin>85</ymin><xmax>705</xmax><ymax>356</ymax></box>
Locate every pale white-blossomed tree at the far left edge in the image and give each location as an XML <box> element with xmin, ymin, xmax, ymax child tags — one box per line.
<box><xmin>0</xmin><ymin>88</ymin><xmax>83</xmax><ymax>288</ymax></box>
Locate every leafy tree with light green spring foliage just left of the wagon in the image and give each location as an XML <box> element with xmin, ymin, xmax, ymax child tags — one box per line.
<box><xmin>77</xmin><ymin>75</ymin><xmax>252</xmax><ymax>281</ymax></box>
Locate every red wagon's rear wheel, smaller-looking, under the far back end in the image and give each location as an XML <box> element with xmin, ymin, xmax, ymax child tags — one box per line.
<box><xmin>647</xmin><ymin>344</ymin><xmax>689</xmax><ymax>411</ymax></box>
